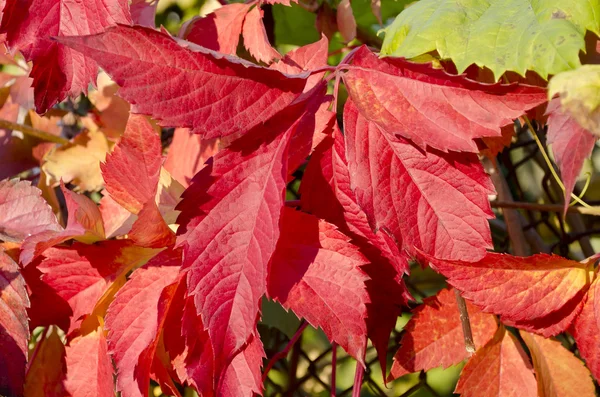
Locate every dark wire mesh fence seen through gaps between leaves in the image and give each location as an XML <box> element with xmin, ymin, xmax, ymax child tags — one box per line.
<box><xmin>261</xmin><ymin>123</ymin><xmax>600</xmax><ymax>397</ymax></box>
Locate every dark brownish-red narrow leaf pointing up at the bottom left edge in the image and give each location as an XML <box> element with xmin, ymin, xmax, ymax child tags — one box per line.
<box><xmin>24</xmin><ymin>327</ymin><xmax>67</xmax><ymax>397</ymax></box>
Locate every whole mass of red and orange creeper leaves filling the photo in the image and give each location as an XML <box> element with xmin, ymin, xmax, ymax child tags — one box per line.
<box><xmin>0</xmin><ymin>0</ymin><xmax>600</xmax><ymax>397</ymax></box>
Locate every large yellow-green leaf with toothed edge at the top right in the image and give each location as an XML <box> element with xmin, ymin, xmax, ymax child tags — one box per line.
<box><xmin>381</xmin><ymin>0</ymin><xmax>600</xmax><ymax>79</ymax></box>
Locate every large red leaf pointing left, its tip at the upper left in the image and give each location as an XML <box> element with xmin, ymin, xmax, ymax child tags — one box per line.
<box><xmin>60</xmin><ymin>26</ymin><xmax>306</xmax><ymax>139</ymax></box>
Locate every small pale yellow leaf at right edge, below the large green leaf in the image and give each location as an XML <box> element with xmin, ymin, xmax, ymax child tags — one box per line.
<box><xmin>548</xmin><ymin>65</ymin><xmax>600</xmax><ymax>136</ymax></box>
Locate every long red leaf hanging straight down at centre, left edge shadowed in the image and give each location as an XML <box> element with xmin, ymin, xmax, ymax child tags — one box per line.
<box><xmin>178</xmin><ymin>100</ymin><xmax>304</xmax><ymax>379</ymax></box>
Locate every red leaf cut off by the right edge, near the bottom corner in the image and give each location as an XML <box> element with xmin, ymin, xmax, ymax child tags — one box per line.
<box><xmin>571</xmin><ymin>279</ymin><xmax>600</xmax><ymax>379</ymax></box>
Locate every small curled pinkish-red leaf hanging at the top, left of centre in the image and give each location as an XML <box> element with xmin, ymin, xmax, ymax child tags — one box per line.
<box><xmin>242</xmin><ymin>5</ymin><xmax>281</xmax><ymax>65</ymax></box>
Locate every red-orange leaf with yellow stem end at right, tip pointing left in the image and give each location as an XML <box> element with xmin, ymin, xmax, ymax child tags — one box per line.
<box><xmin>427</xmin><ymin>252</ymin><xmax>591</xmax><ymax>337</ymax></box>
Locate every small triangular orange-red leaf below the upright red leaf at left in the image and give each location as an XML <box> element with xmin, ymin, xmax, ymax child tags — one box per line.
<box><xmin>129</xmin><ymin>200</ymin><xmax>175</xmax><ymax>248</ymax></box>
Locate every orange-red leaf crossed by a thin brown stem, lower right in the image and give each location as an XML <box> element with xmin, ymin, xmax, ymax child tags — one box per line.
<box><xmin>388</xmin><ymin>289</ymin><xmax>497</xmax><ymax>381</ymax></box>
